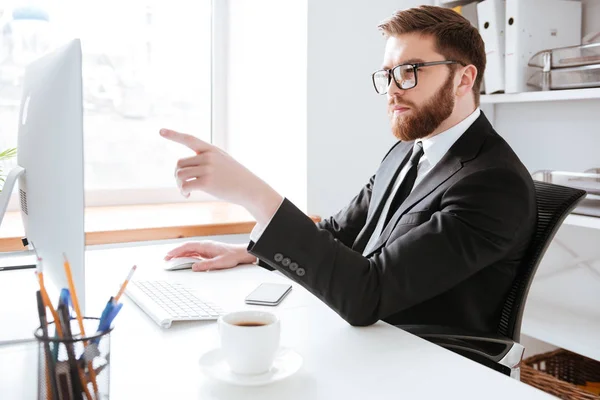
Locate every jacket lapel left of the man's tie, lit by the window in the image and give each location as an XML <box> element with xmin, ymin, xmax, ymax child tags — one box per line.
<box><xmin>352</xmin><ymin>142</ymin><xmax>413</xmax><ymax>252</ymax></box>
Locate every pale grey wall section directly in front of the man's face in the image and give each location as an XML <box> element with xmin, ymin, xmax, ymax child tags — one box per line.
<box><xmin>307</xmin><ymin>0</ymin><xmax>430</xmax><ymax>217</ymax></box>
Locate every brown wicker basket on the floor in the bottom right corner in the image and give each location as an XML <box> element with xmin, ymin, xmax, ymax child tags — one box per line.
<box><xmin>521</xmin><ymin>349</ymin><xmax>600</xmax><ymax>400</ymax></box>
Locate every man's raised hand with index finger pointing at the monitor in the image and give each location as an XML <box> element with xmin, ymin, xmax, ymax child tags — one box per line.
<box><xmin>160</xmin><ymin>129</ymin><xmax>282</xmax><ymax>225</ymax></box>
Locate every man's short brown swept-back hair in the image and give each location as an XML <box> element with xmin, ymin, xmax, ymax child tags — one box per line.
<box><xmin>379</xmin><ymin>6</ymin><xmax>486</xmax><ymax>105</ymax></box>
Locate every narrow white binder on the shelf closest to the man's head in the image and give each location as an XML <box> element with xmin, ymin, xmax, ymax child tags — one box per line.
<box><xmin>477</xmin><ymin>0</ymin><xmax>506</xmax><ymax>94</ymax></box>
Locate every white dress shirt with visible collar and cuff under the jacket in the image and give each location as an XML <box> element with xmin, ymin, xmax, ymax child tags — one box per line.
<box><xmin>250</xmin><ymin>108</ymin><xmax>481</xmax><ymax>255</ymax></box>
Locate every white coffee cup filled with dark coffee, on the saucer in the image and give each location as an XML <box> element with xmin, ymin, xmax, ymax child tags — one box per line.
<box><xmin>218</xmin><ymin>311</ymin><xmax>281</xmax><ymax>375</ymax></box>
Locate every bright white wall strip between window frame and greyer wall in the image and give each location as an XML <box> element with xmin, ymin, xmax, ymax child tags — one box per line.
<box><xmin>226</xmin><ymin>0</ymin><xmax>307</xmax><ymax>209</ymax></box>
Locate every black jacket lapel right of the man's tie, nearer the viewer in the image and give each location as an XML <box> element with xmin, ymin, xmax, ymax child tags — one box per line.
<box><xmin>360</xmin><ymin>112</ymin><xmax>492</xmax><ymax>256</ymax></box>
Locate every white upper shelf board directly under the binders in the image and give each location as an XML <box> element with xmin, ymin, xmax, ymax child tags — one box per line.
<box><xmin>480</xmin><ymin>88</ymin><xmax>600</xmax><ymax>104</ymax></box>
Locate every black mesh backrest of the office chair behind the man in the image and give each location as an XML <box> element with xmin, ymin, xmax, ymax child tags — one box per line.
<box><xmin>498</xmin><ymin>181</ymin><xmax>586</xmax><ymax>342</ymax></box>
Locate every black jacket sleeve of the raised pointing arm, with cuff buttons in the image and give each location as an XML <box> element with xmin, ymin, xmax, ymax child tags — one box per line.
<box><xmin>248</xmin><ymin>168</ymin><xmax>531</xmax><ymax>325</ymax></box>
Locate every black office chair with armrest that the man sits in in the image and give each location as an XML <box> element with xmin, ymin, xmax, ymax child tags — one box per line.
<box><xmin>398</xmin><ymin>181</ymin><xmax>586</xmax><ymax>380</ymax></box>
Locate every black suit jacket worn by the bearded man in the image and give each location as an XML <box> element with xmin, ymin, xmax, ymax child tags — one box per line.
<box><xmin>248</xmin><ymin>113</ymin><xmax>536</xmax><ymax>332</ymax></box>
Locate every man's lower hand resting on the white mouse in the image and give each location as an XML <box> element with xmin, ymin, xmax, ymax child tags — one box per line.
<box><xmin>165</xmin><ymin>240</ymin><xmax>256</xmax><ymax>271</ymax></box>
